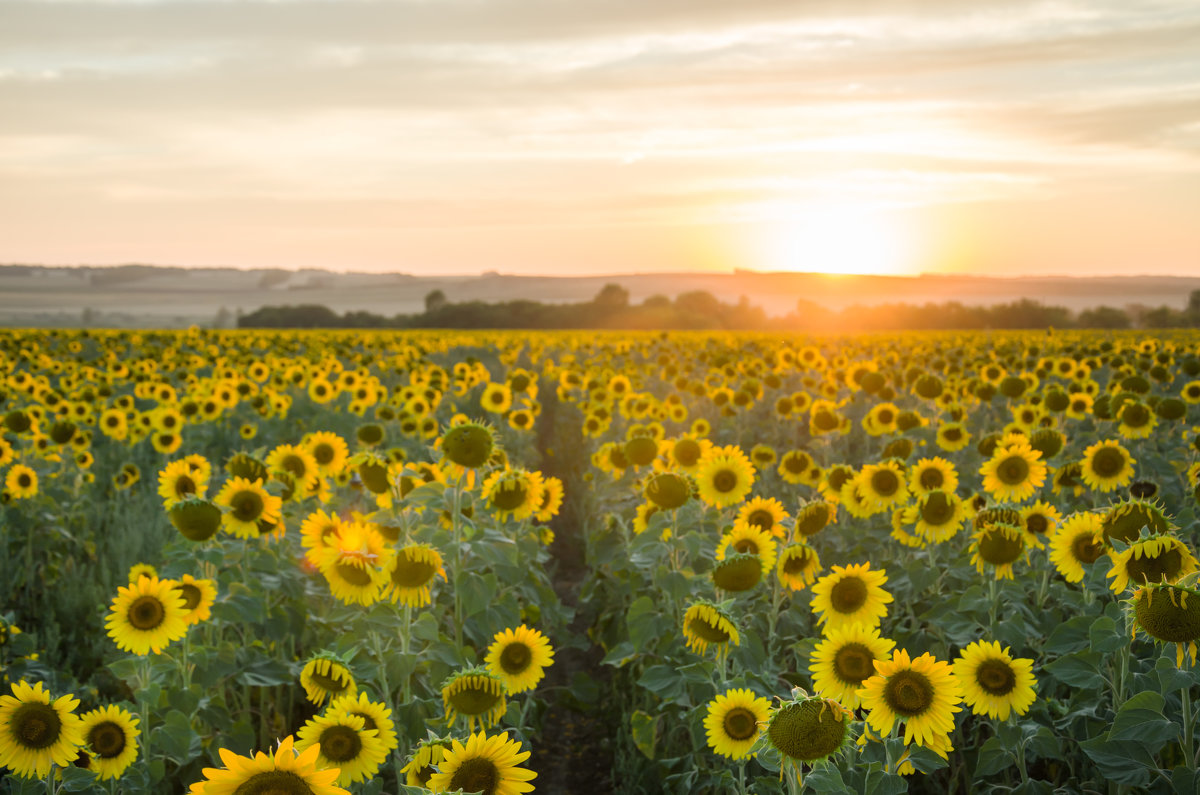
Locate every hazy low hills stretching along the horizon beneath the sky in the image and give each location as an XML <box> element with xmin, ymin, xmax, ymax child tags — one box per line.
<box><xmin>0</xmin><ymin>264</ymin><xmax>1200</xmax><ymax>328</ymax></box>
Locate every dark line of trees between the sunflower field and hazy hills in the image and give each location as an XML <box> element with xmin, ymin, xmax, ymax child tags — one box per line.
<box><xmin>238</xmin><ymin>285</ymin><xmax>1200</xmax><ymax>331</ymax></box>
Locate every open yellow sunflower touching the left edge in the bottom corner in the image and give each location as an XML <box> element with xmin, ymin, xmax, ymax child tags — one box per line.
<box><xmin>0</xmin><ymin>680</ymin><xmax>83</xmax><ymax>778</ymax></box>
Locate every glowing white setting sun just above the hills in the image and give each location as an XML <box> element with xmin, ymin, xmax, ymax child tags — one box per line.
<box><xmin>751</xmin><ymin>203</ymin><xmax>917</xmax><ymax>275</ymax></box>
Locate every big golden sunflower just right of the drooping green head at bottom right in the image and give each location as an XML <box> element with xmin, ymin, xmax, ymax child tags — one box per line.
<box><xmin>858</xmin><ymin>648</ymin><xmax>962</xmax><ymax>746</ymax></box>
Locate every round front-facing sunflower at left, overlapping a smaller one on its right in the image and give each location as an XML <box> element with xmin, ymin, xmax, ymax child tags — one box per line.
<box><xmin>104</xmin><ymin>575</ymin><xmax>187</xmax><ymax>654</ymax></box>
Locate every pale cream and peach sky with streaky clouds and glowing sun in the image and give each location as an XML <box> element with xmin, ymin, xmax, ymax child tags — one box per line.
<box><xmin>0</xmin><ymin>0</ymin><xmax>1200</xmax><ymax>276</ymax></box>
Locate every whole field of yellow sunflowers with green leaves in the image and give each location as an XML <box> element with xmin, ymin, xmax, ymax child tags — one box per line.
<box><xmin>0</xmin><ymin>329</ymin><xmax>1200</xmax><ymax>795</ymax></box>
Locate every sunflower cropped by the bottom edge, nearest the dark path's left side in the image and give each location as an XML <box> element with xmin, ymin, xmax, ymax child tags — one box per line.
<box><xmin>426</xmin><ymin>731</ymin><xmax>538</xmax><ymax>795</ymax></box>
